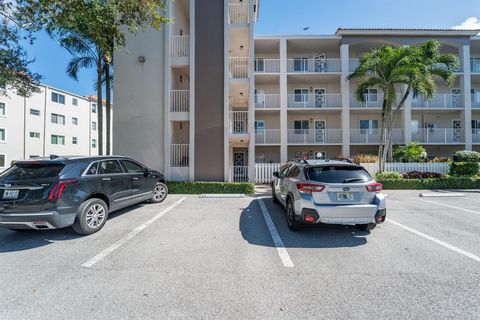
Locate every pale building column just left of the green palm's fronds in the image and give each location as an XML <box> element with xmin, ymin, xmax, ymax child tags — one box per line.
<box><xmin>340</xmin><ymin>44</ymin><xmax>350</xmax><ymax>157</ymax></box>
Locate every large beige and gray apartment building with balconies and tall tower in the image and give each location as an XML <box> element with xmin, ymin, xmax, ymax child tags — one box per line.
<box><xmin>114</xmin><ymin>0</ymin><xmax>480</xmax><ymax>181</ymax></box>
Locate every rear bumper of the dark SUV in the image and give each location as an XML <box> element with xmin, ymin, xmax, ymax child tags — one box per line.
<box><xmin>0</xmin><ymin>211</ymin><xmax>76</xmax><ymax>230</ymax></box>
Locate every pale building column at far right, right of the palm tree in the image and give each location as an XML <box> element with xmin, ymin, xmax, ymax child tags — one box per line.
<box><xmin>460</xmin><ymin>45</ymin><xmax>472</xmax><ymax>150</ymax></box>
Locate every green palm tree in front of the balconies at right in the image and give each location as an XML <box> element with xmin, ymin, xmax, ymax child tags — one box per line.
<box><xmin>348</xmin><ymin>41</ymin><xmax>458</xmax><ymax>172</ymax></box>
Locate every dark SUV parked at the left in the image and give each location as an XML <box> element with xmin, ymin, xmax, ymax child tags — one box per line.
<box><xmin>0</xmin><ymin>156</ymin><xmax>168</xmax><ymax>234</ymax></box>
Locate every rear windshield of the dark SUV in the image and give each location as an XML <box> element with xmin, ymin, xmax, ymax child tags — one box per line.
<box><xmin>0</xmin><ymin>163</ymin><xmax>65</xmax><ymax>181</ymax></box>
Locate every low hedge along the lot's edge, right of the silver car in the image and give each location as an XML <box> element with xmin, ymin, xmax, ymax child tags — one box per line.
<box><xmin>379</xmin><ymin>177</ymin><xmax>480</xmax><ymax>190</ymax></box>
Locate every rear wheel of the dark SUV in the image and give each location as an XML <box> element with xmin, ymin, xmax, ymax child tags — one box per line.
<box><xmin>72</xmin><ymin>198</ymin><xmax>108</xmax><ymax>235</ymax></box>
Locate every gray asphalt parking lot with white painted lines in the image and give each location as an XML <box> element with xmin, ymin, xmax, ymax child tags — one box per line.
<box><xmin>0</xmin><ymin>191</ymin><xmax>480</xmax><ymax>319</ymax></box>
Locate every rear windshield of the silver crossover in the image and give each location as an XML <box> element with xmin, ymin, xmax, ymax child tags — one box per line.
<box><xmin>307</xmin><ymin>165</ymin><xmax>372</xmax><ymax>183</ymax></box>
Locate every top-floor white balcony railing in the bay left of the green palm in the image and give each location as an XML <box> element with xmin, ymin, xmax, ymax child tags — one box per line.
<box><xmin>287</xmin><ymin>58</ymin><xmax>342</xmax><ymax>73</ymax></box>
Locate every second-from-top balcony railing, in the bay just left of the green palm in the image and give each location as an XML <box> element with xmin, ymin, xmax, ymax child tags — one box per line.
<box><xmin>288</xmin><ymin>93</ymin><xmax>342</xmax><ymax>109</ymax></box>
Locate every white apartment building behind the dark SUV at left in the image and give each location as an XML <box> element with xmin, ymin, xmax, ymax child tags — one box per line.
<box><xmin>0</xmin><ymin>85</ymin><xmax>109</xmax><ymax>170</ymax></box>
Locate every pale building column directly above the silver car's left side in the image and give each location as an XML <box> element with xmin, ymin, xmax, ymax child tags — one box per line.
<box><xmin>280</xmin><ymin>38</ymin><xmax>288</xmax><ymax>163</ymax></box>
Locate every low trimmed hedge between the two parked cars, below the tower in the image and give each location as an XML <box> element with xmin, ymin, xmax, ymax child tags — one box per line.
<box><xmin>167</xmin><ymin>181</ymin><xmax>255</xmax><ymax>194</ymax></box>
